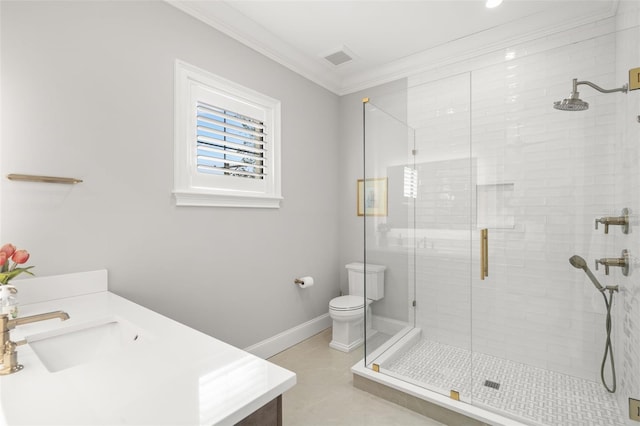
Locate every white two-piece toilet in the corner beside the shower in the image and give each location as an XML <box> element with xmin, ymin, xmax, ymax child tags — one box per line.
<box><xmin>329</xmin><ymin>263</ymin><xmax>386</xmax><ymax>352</ymax></box>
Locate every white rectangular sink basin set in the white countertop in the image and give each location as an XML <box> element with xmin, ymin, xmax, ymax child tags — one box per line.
<box><xmin>26</xmin><ymin>317</ymin><xmax>142</xmax><ymax>373</ymax></box>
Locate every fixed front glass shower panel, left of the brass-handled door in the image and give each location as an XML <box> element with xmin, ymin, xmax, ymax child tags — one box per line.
<box><xmin>365</xmin><ymin>74</ymin><xmax>478</xmax><ymax>402</ymax></box>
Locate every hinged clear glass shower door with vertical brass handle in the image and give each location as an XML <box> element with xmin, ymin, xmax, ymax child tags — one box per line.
<box><xmin>471</xmin><ymin>34</ymin><xmax>630</xmax><ymax>426</ymax></box>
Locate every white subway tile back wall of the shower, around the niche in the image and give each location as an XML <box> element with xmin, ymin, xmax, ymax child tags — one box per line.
<box><xmin>408</xmin><ymin>29</ymin><xmax>616</xmax><ymax>380</ymax></box>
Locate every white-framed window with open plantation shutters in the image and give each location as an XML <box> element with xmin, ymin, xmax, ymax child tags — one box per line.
<box><xmin>173</xmin><ymin>61</ymin><xmax>282</xmax><ymax>208</ymax></box>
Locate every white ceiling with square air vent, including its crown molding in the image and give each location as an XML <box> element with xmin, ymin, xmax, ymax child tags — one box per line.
<box><xmin>167</xmin><ymin>0</ymin><xmax>618</xmax><ymax>95</ymax></box>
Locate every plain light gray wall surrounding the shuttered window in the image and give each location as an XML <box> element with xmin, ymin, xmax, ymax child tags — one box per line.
<box><xmin>0</xmin><ymin>1</ymin><xmax>340</xmax><ymax>347</ymax></box>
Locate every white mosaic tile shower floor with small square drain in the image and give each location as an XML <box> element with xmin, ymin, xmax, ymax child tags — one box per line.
<box><xmin>382</xmin><ymin>339</ymin><xmax>625</xmax><ymax>426</ymax></box>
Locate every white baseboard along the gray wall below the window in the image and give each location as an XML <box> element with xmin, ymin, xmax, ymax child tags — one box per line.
<box><xmin>244</xmin><ymin>312</ymin><xmax>333</xmax><ymax>359</ymax></box>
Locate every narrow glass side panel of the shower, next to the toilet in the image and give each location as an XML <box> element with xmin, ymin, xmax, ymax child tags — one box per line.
<box><xmin>357</xmin><ymin>93</ymin><xmax>416</xmax><ymax>369</ymax></box>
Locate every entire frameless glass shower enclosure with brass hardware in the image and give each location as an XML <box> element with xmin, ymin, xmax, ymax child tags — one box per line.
<box><xmin>359</xmin><ymin>25</ymin><xmax>639</xmax><ymax>426</ymax></box>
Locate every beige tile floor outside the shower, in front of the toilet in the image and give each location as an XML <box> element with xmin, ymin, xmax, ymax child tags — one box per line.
<box><xmin>269</xmin><ymin>328</ymin><xmax>444</xmax><ymax>426</ymax></box>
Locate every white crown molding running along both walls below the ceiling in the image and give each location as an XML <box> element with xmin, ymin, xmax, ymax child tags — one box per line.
<box><xmin>165</xmin><ymin>0</ymin><xmax>620</xmax><ymax>96</ymax></box>
